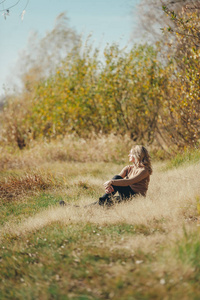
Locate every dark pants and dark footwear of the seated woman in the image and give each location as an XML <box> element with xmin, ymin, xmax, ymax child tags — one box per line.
<box><xmin>99</xmin><ymin>175</ymin><xmax>136</xmax><ymax>205</ymax></box>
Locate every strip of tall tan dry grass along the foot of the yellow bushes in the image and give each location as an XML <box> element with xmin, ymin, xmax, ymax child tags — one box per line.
<box><xmin>0</xmin><ymin>134</ymin><xmax>146</xmax><ymax>170</ymax></box>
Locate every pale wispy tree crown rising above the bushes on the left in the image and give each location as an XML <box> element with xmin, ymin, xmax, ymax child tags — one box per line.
<box><xmin>18</xmin><ymin>13</ymin><xmax>80</xmax><ymax>90</ymax></box>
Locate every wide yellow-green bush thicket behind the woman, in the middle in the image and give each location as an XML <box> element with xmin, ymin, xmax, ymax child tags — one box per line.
<box><xmin>0</xmin><ymin>45</ymin><xmax>167</xmax><ymax>148</ymax></box>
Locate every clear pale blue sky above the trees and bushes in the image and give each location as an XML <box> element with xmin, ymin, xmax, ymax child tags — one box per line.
<box><xmin>0</xmin><ymin>0</ymin><xmax>140</xmax><ymax>95</ymax></box>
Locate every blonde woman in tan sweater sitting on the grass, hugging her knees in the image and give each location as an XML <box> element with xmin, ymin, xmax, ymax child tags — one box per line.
<box><xmin>99</xmin><ymin>145</ymin><xmax>152</xmax><ymax>205</ymax></box>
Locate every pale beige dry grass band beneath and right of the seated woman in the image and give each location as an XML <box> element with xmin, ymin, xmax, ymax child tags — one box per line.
<box><xmin>1</xmin><ymin>159</ymin><xmax>200</xmax><ymax>246</ymax></box>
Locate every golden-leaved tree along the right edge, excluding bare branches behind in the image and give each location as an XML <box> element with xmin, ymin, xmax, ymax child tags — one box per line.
<box><xmin>159</xmin><ymin>1</ymin><xmax>200</xmax><ymax>147</ymax></box>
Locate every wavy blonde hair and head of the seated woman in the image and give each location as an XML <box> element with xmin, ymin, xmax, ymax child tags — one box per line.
<box><xmin>131</xmin><ymin>145</ymin><xmax>153</xmax><ymax>174</ymax></box>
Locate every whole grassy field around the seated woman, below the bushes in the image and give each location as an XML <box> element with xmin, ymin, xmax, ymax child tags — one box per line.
<box><xmin>0</xmin><ymin>141</ymin><xmax>200</xmax><ymax>300</ymax></box>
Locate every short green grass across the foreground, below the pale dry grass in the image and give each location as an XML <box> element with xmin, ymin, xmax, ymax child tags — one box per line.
<box><xmin>0</xmin><ymin>223</ymin><xmax>200</xmax><ymax>299</ymax></box>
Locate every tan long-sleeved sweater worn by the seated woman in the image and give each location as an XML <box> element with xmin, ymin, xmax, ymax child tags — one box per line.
<box><xmin>112</xmin><ymin>165</ymin><xmax>150</xmax><ymax>196</ymax></box>
